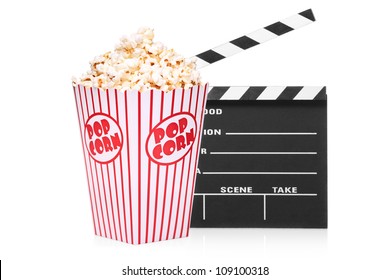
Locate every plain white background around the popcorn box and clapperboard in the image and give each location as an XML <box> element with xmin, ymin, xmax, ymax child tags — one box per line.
<box><xmin>0</xmin><ymin>0</ymin><xmax>390</xmax><ymax>279</ymax></box>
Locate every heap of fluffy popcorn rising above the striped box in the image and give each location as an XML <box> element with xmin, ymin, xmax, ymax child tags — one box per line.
<box><xmin>72</xmin><ymin>27</ymin><xmax>202</xmax><ymax>91</ymax></box>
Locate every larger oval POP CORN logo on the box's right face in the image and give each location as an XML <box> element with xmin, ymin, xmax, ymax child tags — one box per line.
<box><xmin>145</xmin><ymin>113</ymin><xmax>197</xmax><ymax>165</ymax></box>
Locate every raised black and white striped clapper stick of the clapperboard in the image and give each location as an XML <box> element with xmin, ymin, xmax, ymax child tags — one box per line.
<box><xmin>195</xmin><ymin>9</ymin><xmax>315</xmax><ymax>69</ymax></box>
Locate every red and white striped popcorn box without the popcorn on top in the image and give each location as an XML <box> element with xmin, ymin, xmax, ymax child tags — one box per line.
<box><xmin>74</xmin><ymin>84</ymin><xmax>208</xmax><ymax>244</ymax></box>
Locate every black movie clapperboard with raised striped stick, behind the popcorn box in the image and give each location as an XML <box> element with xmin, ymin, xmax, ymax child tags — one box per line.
<box><xmin>191</xmin><ymin>10</ymin><xmax>327</xmax><ymax>228</ymax></box>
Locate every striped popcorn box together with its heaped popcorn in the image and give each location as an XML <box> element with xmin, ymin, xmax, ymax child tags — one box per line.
<box><xmin>73</xmin><ymin>28</ymin><xmax>207</xmax><ymax>244</ymax></box>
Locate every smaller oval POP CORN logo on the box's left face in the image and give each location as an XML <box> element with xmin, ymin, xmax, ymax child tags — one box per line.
<box><xmin>84</xmin><ymin>113</ymin><xmax>123</xmax><ymax>163</ymax></box>
